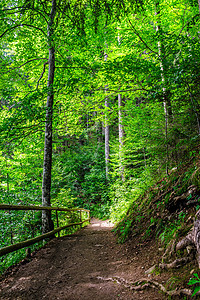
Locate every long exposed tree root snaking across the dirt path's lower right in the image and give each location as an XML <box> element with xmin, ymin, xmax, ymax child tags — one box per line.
<box><xmin>97</xmin><ymin>276</ymin><xmax>194</xmax><ymax>297</ymax></box>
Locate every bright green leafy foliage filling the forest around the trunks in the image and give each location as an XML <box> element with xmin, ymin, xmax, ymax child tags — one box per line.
<box><xmin>0</xmin><ymin>0</ymin><xmax>200</xmax><ymax>278</ymax></box>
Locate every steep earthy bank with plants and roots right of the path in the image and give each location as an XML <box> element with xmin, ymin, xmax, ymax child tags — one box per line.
<box><xmin>115</xmin><ymin>157</ymin><xmax>200</xmax><ymax>296</ymax></box>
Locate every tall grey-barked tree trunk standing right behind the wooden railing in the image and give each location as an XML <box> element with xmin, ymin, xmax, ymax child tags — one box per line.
<box><xmin>42</xmin><ymin>0</ymin><xmax>56</xmax><ymax>233</ymax></box>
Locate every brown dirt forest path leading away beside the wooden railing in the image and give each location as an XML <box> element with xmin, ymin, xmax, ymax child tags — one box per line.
<box><xmin>0</xmin><ymin>219</ymin><xmax>167</xmax><ymax>300</ymax></box>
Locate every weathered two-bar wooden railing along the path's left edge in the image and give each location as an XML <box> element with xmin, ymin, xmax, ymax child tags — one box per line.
<box><xmin>0</xmin><ymin>204</ymin><xmax>90</xmax><ymax>257</ymax></box>
